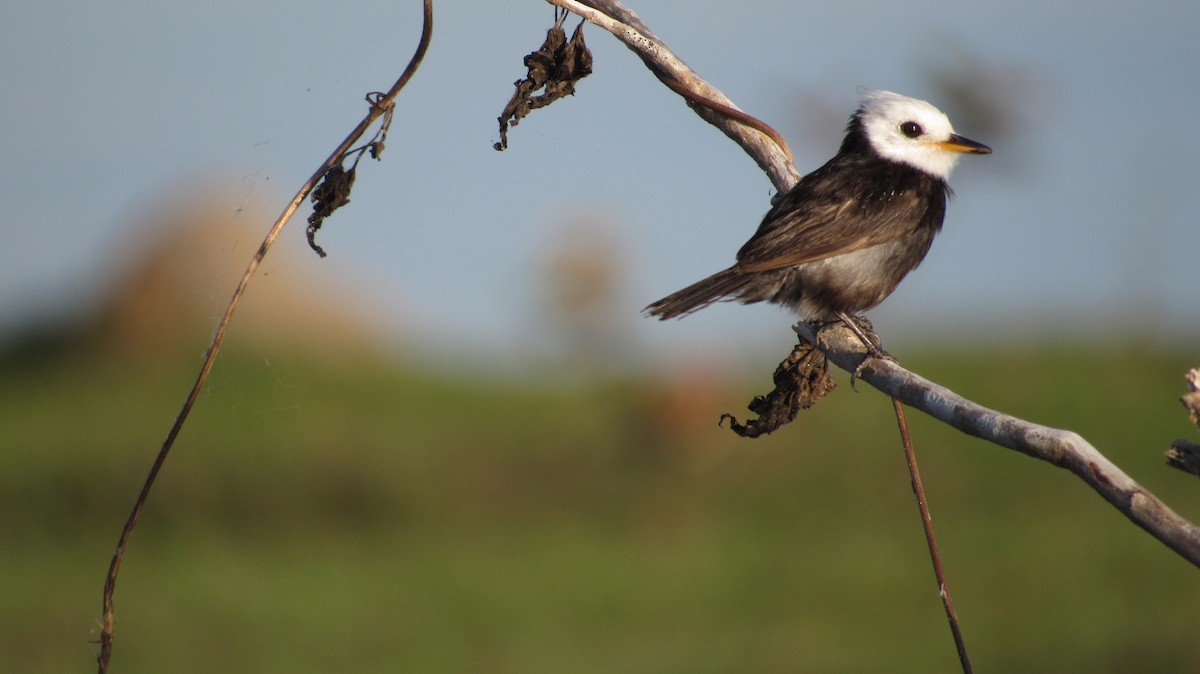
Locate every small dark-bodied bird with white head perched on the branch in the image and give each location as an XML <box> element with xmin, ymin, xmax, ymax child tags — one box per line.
<box><xmin>644</xmin><ymin>91</ymin><xmax>991</xmax><ymax>340</ymax></box>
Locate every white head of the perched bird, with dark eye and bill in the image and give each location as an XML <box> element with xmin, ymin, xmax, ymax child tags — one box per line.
<box><xmin>854</xmin><ymin>91</ymin><xmax>991</xmax><ymax>180</ymax></box>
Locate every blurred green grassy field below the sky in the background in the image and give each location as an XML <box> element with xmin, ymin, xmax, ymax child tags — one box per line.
<box><xmin>0</xmin><ymin>347</ymin><xmax>1200</xmax><ymax>674</ymax></box>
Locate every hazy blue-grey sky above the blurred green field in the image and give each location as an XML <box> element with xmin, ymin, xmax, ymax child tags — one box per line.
<box><xmin>0</xmin><ymin>0</ymin><xmax>1200</xmax><ymax>362</ymax></box>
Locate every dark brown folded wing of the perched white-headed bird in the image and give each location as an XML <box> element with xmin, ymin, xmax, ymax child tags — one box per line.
<box><xmin>737</xmin><ymin>160</ymin><xmax>941</xmax><ymax>272</ymax></box>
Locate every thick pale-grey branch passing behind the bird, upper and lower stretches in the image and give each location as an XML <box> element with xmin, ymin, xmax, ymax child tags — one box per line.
<box><xmin>547</xmin><ymin>0</ymin><xmax>1200</xmax><ymax>566</ymax></box>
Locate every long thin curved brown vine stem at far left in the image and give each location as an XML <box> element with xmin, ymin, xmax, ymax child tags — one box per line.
<box><xmin>96</xmin><ymin>0</ymin><xmax>433</xmax><ymax>674</ymax></box>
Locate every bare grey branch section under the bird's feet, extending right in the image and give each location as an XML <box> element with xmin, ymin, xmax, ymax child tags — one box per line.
<box><xmin>794</xmin><ymin>323</ymin><xmax>1200</xmax><ymax>566</ymax></box>
